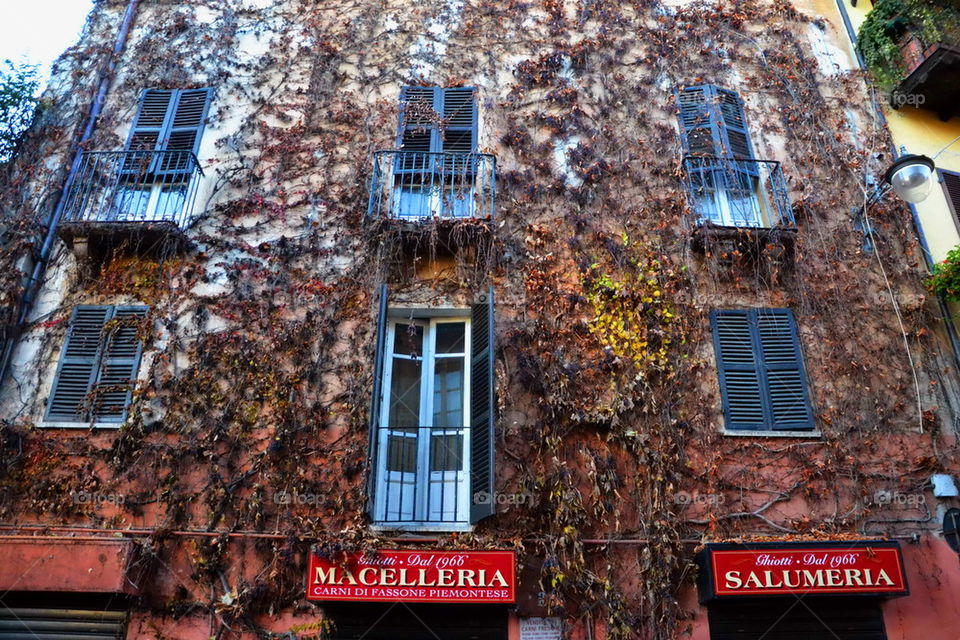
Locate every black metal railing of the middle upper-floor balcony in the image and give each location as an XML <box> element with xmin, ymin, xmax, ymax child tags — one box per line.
<box><xmin>367</xmin><ymin>150</ymin><xmax>497</xmax><ymax>220</ymax></box>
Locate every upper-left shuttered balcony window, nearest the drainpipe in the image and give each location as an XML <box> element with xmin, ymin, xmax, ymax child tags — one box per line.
<box><xmin>114</xmin><ymin>89</ymin><xmax>211</xmax><ymax>221</ymax></box>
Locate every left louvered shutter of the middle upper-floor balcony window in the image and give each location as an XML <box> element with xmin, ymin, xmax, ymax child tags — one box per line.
<box><xmin>395</xmin><ymin>87</ymin><xmax>443</xmax><ymax>173</ymax></box>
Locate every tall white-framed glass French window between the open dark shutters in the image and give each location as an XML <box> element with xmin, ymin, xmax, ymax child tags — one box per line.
<box><xmin>375</xmin><ymin>318</ymin><xmax>470</xmax><ymax>525</ymax></box>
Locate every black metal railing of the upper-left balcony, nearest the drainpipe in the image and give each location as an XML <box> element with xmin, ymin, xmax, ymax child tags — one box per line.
<box><xmin>63</xmin><ymin>150</ymin><xmax>203</xmax><ymax>227</ymax></box>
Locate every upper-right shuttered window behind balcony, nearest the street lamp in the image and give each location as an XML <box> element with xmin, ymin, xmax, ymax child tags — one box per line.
<box><xmin>677</xmin><ymin>85</ymin><xmax>783</xmax><ymax>227</ymax></box>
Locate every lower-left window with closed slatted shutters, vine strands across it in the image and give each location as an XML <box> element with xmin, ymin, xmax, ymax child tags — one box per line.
<box><xmin>46</xmin><ymin>305</ymin><xmax>147</xmax><ymax>423</ymax></box>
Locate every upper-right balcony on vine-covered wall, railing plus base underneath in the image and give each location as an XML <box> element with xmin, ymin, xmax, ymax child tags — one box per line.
<box><xmin>683</xmin><ymin>156</ymin><xmax>796</xmax><ymax>254</ymax></box>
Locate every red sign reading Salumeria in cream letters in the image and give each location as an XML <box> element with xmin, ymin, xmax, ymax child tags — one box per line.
<box><xmin>708</xmin><ymin>543</ymin><xmax>907</xmax><ymax>596</ymax></box>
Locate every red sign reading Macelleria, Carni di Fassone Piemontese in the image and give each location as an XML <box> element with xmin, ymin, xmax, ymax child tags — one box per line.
<box><xmin>307</xmin><ymin>551</ymin><xmax>517</xmax><ymax>603</ymax></box>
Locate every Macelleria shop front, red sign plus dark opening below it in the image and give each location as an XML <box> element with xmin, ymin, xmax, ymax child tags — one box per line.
<box><xmin>307</xmin><ymin>550</ymin><xmax>517</xmax><ymax>640</ymax></box>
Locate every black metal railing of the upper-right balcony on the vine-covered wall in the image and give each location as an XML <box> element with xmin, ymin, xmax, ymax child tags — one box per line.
<box><xmin>683</xmin><ymin>156</ymin><xmax>796</xmax><ymax>228</ymax></box>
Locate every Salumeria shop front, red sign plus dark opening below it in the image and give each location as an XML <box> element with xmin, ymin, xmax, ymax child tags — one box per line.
<box><xmin>698</xmin><ymin>540</ymin><xmax>908</xmax><ymax>640</ymax></box>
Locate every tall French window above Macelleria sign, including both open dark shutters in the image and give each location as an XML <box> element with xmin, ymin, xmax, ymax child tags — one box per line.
<box><xmin>370</xmin><ymin>287</ymin><xmax>493</xmax><ymax>527</ymax></box>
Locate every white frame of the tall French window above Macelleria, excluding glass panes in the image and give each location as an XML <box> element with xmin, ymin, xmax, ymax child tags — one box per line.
<box><xmin>374</xmin><ymin>316</ymin><xmax>471</xmax><ymax>531</ymax></box>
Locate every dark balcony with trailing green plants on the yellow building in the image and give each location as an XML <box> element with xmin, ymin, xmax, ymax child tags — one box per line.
<box><xmin>857</xmin><ymin>0</ymin><xmax>960</xmax><ymax>121</ymax></box>
